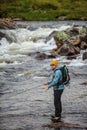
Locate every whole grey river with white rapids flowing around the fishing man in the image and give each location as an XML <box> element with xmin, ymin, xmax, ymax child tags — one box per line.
<box><xmin>0</xmin><ymin>21</ymin><xmax>87</xmax><ymax>130</ymax></box>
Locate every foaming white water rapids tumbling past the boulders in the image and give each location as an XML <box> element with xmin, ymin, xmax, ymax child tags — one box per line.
<box><xmin>0</xmin><ymin>23</ymin><xmax>86</xmax><ymax>66</ymax></box>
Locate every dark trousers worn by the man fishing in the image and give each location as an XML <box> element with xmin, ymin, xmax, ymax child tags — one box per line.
<box><xmin>54</xmin><ymin>90</ymin><xmax>63</xmax><ymax>117</ymax></box>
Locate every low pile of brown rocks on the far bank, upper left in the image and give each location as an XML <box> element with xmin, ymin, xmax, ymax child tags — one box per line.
<box><xmin>0</xmin><ymin>18</ymin><xmax>17</xmax><ymax>29</ymax></box>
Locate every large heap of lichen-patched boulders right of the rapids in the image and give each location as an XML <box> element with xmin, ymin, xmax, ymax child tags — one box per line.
<box><xmin>46</xmin><ymin>26</ymin><xmax>87</xmax><ymax>59</ymax></box>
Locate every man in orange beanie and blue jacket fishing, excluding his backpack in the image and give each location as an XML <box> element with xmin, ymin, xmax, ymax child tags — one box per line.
<box><xmin>44</xmin><ymin>60</ymin><xmax>64</xmax><ymax>122</ymax></box>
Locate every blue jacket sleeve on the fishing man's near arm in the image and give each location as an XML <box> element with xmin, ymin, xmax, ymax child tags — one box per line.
<box><xmin>48</xmin><ymin>70</ymin><xmax>61</xmax><ymax>89</ymax></box>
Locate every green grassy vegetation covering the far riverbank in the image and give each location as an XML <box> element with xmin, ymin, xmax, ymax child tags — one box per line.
<box><xmin>0</xmin><ymin>0</ymin><xmax>87</xmax><ymax>21</ymax></box>
